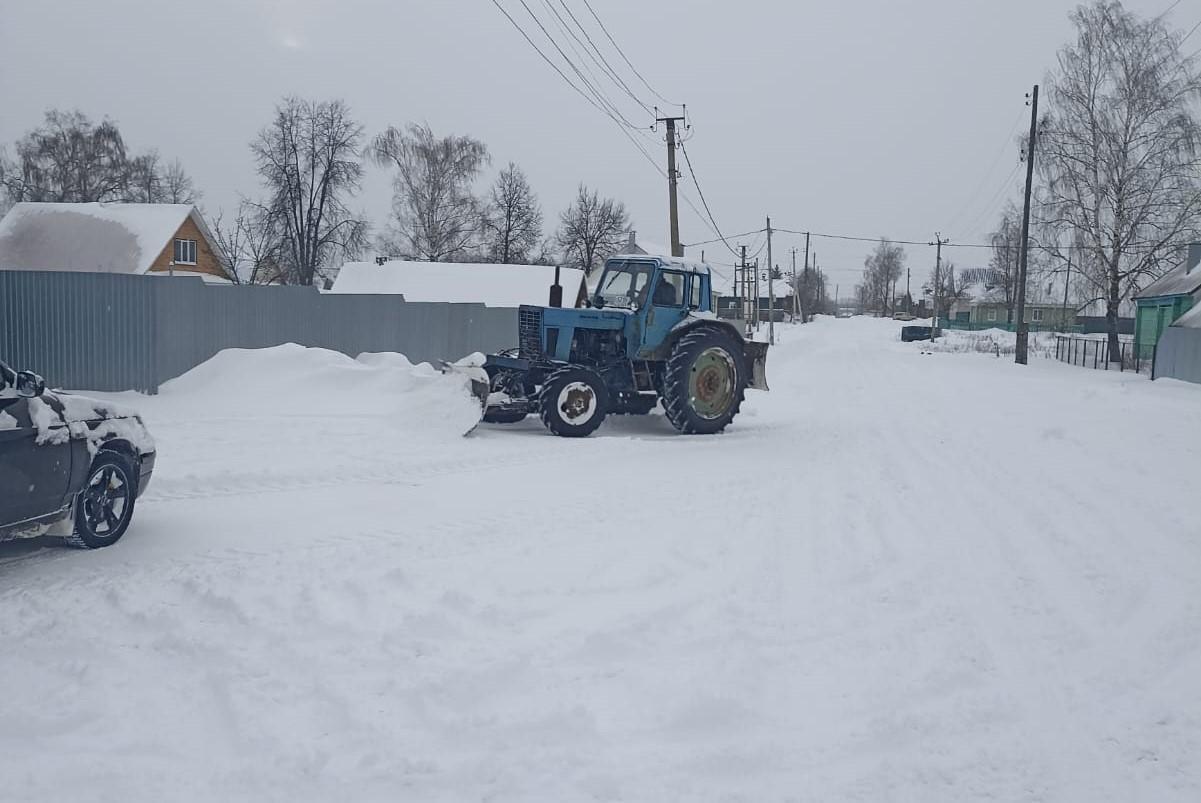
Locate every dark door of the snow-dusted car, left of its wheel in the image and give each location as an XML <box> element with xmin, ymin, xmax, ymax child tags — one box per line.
<box><xmin>0</xmin><ymin>388</ymin><xmax>71</xmax><ymax>526</ymax></box>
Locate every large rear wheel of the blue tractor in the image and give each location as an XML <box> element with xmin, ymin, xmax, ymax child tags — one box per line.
<box><xmin>663</xmin><ymin>328</ymin><xmax>747</xmax><ymax>435</ymax></box>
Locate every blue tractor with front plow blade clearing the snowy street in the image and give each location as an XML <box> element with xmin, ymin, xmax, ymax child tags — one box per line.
<box><xmin>470</xmin><ymin>256</ymin><xmax>767</xmax><ymax>438</ymax></box>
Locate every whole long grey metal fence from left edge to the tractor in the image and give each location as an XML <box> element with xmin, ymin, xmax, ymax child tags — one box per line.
<box><xmin>0</xmin><ymin>270</ymin><xmax>516</xmax><ymax>392</ymax></box>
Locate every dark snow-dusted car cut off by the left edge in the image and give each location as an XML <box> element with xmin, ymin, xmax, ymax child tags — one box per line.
<box><xmin>0</xmin><ymin>361</ymin><xmax>155</xmax><ymax>549</ymax></box>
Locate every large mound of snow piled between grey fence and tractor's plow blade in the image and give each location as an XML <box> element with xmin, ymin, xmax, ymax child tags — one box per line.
<box><xmin>160</xmin><ymin>343</ymin><xmax>479</xmax><ymax>439</ymax></box>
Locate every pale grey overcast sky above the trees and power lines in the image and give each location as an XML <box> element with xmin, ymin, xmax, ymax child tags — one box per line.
<box><xmin>0</xmin><ymin>0</ymin><xmax>1201</xmax><ymax>292</ymax></box>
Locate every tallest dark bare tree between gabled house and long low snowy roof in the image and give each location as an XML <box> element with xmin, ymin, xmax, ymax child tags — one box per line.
<box><xmin>251</xmin><ymin>97</ymin><xmax>368</xmax><ymax>284</ymax></box>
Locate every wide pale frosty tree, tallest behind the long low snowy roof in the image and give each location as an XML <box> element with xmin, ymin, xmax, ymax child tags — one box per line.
<box><xmin>368</xmin><ymin>125</ymin><xmax>489</xmax><ymax>262</ymax></box>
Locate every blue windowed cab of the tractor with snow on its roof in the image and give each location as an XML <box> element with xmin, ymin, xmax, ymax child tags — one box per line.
<box><xmin>590</xmin><ymin>256</ymin><xmax>712</xmax><ymax>359</ymax></box>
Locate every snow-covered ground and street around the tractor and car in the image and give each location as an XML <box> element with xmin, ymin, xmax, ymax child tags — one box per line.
<box><xmin>0</xmin><ymin>318</ymin><xmax>1201</xmax><ymax>803</ymax></box>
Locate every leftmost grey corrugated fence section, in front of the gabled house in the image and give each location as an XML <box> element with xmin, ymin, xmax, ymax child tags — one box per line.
<box><xmin>0</xmin><ymin>270</ymin><xmax>157</xmax><ymax>391</ymax></box>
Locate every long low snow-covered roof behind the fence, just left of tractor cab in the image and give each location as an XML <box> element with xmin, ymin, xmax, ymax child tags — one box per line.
<box><xmin>330</xmin><ymin>260</ymin><xmax>584</xmax><ymax>307</ymax></box>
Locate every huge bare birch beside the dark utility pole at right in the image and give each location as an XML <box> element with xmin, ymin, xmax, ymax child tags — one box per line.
<box><xmin>1039</xmin><ymin>0</ymin><xmax>1201</xmax><ymax>354</ymax></box>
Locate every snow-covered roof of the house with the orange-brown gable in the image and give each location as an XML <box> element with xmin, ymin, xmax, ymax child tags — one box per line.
<box><xmin>0</xmin><ymin>202</ymin><xmax>216</xmax><ymax>274</ymax></box>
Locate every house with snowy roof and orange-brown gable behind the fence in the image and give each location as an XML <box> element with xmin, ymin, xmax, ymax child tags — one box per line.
<box><xmin>0</xmin><ymin>202</ymin><xmax>229</xmax><ymax>283</ymax></box>
